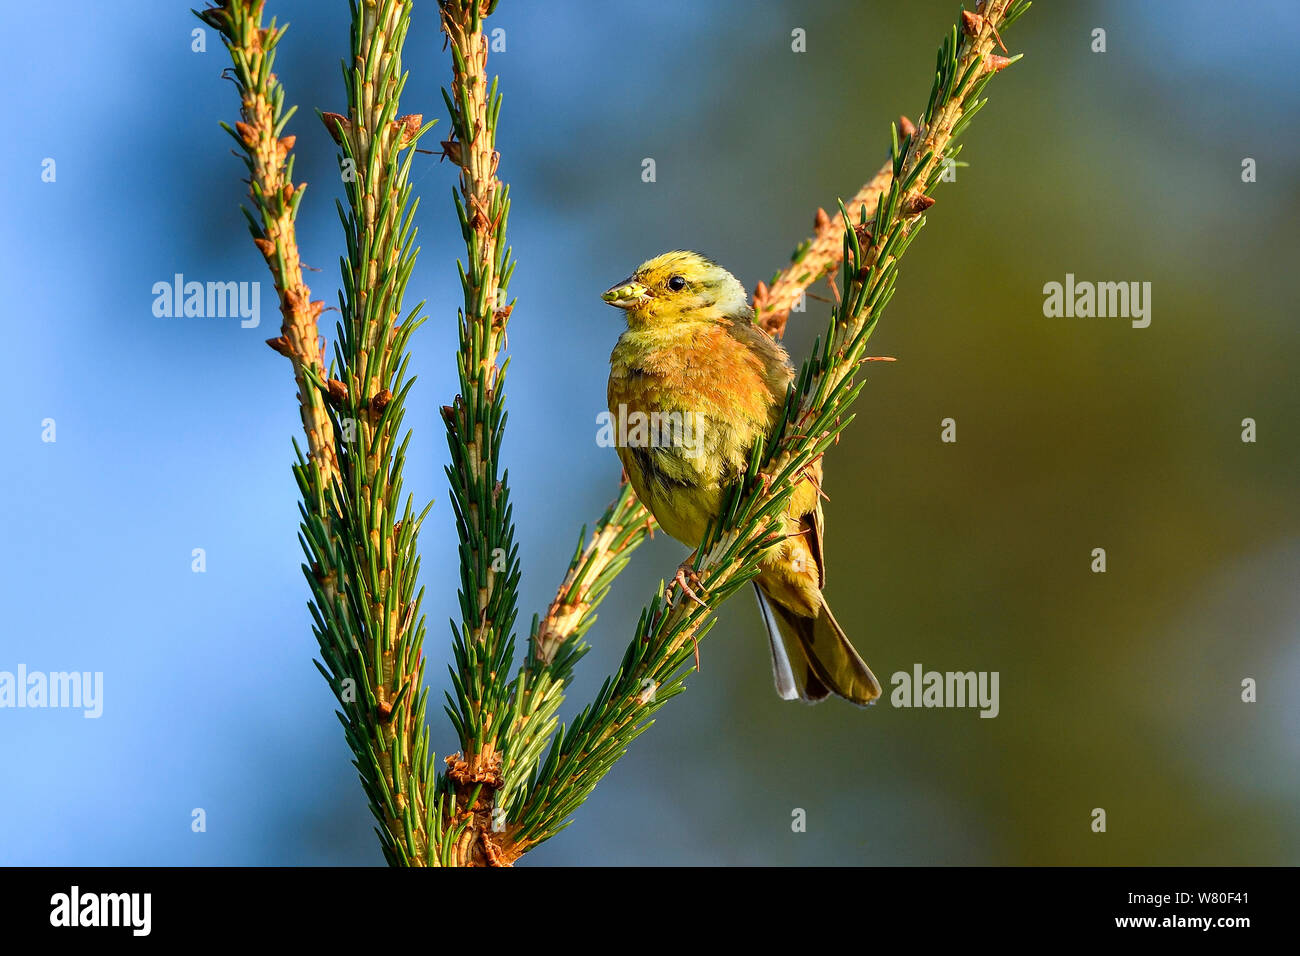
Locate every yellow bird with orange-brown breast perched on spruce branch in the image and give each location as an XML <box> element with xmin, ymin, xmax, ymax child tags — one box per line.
<box><xmin>601</xmin><ymin>251</ymin><xmax>880</xmax><ymax>705</ymax></box>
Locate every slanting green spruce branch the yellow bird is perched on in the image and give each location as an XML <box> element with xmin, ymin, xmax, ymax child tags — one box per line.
<box><xmin>510</xmin><ymin>0</ymin><xmax>1030</xmax><ymax>852</ymax></box>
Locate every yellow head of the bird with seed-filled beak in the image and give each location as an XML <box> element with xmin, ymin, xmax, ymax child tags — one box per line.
<box><xmin>601</xmin><ymin>251</ymin><xmax>749</xmax><ymax>326</ymax></box>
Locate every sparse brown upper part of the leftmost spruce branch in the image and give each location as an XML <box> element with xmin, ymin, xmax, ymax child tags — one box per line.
<box><xmin>194</xmin><ymin>0</ymin><xmax>338</xmax><ymax>489</ymax></box>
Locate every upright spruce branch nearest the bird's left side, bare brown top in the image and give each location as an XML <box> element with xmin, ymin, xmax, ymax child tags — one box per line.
<box><xmin>438</xmin><ymin>0</ymin><xmax>527</xmax><ymax>864</ymax></box>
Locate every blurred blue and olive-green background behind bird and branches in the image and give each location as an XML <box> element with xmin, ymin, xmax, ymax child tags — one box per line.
<box><xmin>0</xmin><ymin>0</ymin><xmax>1300</xmax><ymax>865</ymax></box>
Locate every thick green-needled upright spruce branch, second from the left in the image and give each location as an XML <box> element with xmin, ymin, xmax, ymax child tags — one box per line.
<box><xmin>314</xmin><ymin>0</ymin><xmax>445</xmax><ymax>865</ymax></box>
